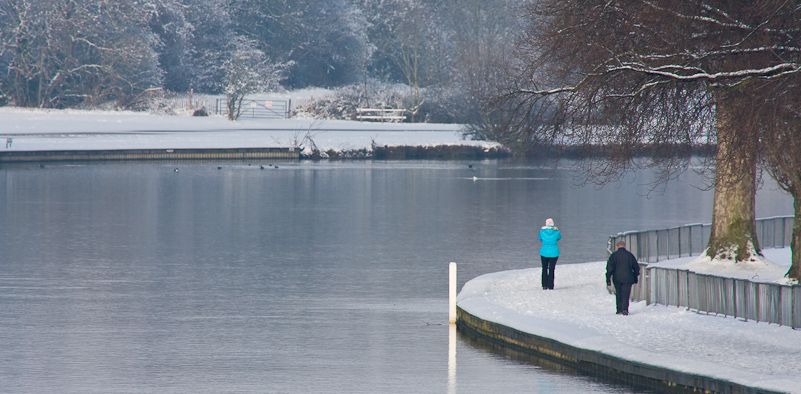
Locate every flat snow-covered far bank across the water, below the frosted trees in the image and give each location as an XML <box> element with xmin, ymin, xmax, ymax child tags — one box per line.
<box><xmin>0</xmin><ymin>107</ymin><xmax>497</xmax><ymax>158</ymax></box>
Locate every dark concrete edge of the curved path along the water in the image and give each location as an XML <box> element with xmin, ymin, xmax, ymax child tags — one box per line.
<box><xmin>456</xmin><ymin>306</ymin><xmax>780</xmax><ymax>394</ymax></box>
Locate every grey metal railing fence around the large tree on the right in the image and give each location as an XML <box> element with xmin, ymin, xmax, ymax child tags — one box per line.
<box><xmin>607</xmin><ymin>216</ymin><xmax>801</xmax><ymax>328</ymax></box>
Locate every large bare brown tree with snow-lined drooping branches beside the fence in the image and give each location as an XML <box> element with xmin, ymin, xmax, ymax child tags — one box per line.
<box><xmin>500</xmin><ymin>0</ymin><xmax>801</xmax><ymax>268</ymax></box>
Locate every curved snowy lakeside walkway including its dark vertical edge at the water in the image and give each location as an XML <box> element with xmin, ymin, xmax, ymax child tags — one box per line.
<box><xmin>457</xmin><ymin>249</ymin><xmax>801</xmax><ymax>393</ymax></box>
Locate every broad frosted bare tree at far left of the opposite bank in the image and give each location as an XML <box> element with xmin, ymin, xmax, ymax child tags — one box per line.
<box><xmin>0</xmin><ymin>0</ymin><xmax>161</xmax><ymax>107</ymax></box>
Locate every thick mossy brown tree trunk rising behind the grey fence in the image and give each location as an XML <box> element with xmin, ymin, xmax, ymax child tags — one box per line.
<box><xmin>707</xmin><ymin>93</ymin><xmax>760</xmax><ymax>261</ymax></box>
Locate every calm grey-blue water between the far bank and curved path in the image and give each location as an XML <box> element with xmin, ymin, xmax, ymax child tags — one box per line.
<box><xmin>0</xmin><ymin>161</ymin><xmax>792</xmax><ymax>393</ymax></box>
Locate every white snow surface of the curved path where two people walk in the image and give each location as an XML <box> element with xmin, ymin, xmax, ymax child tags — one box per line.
<box><xmin>457</xmin><ymin>249</ymin><xmax>801</xmax><ymax>393</ymax></box>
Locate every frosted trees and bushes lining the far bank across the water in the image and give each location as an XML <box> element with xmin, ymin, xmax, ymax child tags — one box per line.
<box><xmin>0</xmin><ymin>0</ymin><xmax>522</xmax><ymax>127</ymax></box>
